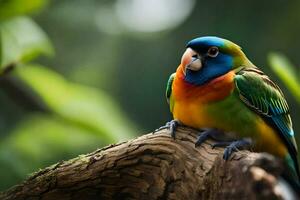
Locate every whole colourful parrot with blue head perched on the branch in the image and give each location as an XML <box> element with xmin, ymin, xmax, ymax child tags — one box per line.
<box><xmin>156</xmin><ymin>36</ymin><xmax>300</xmax><ymax>189</ymax></box>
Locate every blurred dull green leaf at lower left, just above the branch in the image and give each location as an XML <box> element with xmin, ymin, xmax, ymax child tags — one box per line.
<box><xmin>0</xmin><ymin>114</ymin><xmax>104</xmax><ymax>190</ymax></box>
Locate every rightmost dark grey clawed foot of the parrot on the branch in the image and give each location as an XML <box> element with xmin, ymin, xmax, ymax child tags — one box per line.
<box><xmin>212</xmin><ymin>138</ymin><xmax>252</xmax><ymax>160</ymax></box>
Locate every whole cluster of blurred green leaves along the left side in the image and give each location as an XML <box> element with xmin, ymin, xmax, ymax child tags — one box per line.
<box><xmin>0</xmin><ymin>0</ymin><xmax>136</xmax><ymax>190</ymax></box>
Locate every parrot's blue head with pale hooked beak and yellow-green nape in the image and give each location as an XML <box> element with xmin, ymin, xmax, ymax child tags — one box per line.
<box><xmin>181</xmin><ymin>36</ymin><xmax>251</xmax><ymax>85</ymax></box>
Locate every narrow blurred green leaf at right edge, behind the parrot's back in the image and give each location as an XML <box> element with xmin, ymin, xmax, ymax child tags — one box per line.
<box><xmin>268</xmin><ymin>52</ymin><xmax>300</xmax><ymax>103</ymax></box>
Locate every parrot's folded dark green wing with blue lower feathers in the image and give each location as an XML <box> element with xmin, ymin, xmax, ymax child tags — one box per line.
<box><xmin>234</xmin><ymin>67</ymin><xmax>297</xmax><ymax>158</ymax></box>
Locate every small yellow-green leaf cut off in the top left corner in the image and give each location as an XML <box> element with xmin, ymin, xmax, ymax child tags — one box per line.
<box><xmin>0</xmin><ymin>0</ymin><xmax>47</xmax><ymax>20</ymax></box>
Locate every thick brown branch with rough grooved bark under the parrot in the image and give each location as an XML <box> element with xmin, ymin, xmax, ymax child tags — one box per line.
<box><xmin>0</xmin><ymin>127</ymin><xmax>292</xmax><ymax>200</ymax></box>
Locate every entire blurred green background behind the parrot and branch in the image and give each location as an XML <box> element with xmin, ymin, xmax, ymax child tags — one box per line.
<box><xmin>0</xmin><ymin>0</ymin><xmax>300</xmax><ymax>190</ymax></box>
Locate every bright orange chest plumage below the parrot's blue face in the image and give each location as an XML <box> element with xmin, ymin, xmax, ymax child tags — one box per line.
<box><xmin>172</xmin><ymin>68</ymin><xmax>235</xmax><ymax>128</ymax></box>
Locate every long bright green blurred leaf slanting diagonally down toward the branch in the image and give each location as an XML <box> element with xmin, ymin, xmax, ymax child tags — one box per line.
<box><xmin>15</xmin><ymin>65</ymin><xmax>136</xmax><ymax>143</ymax></box>
